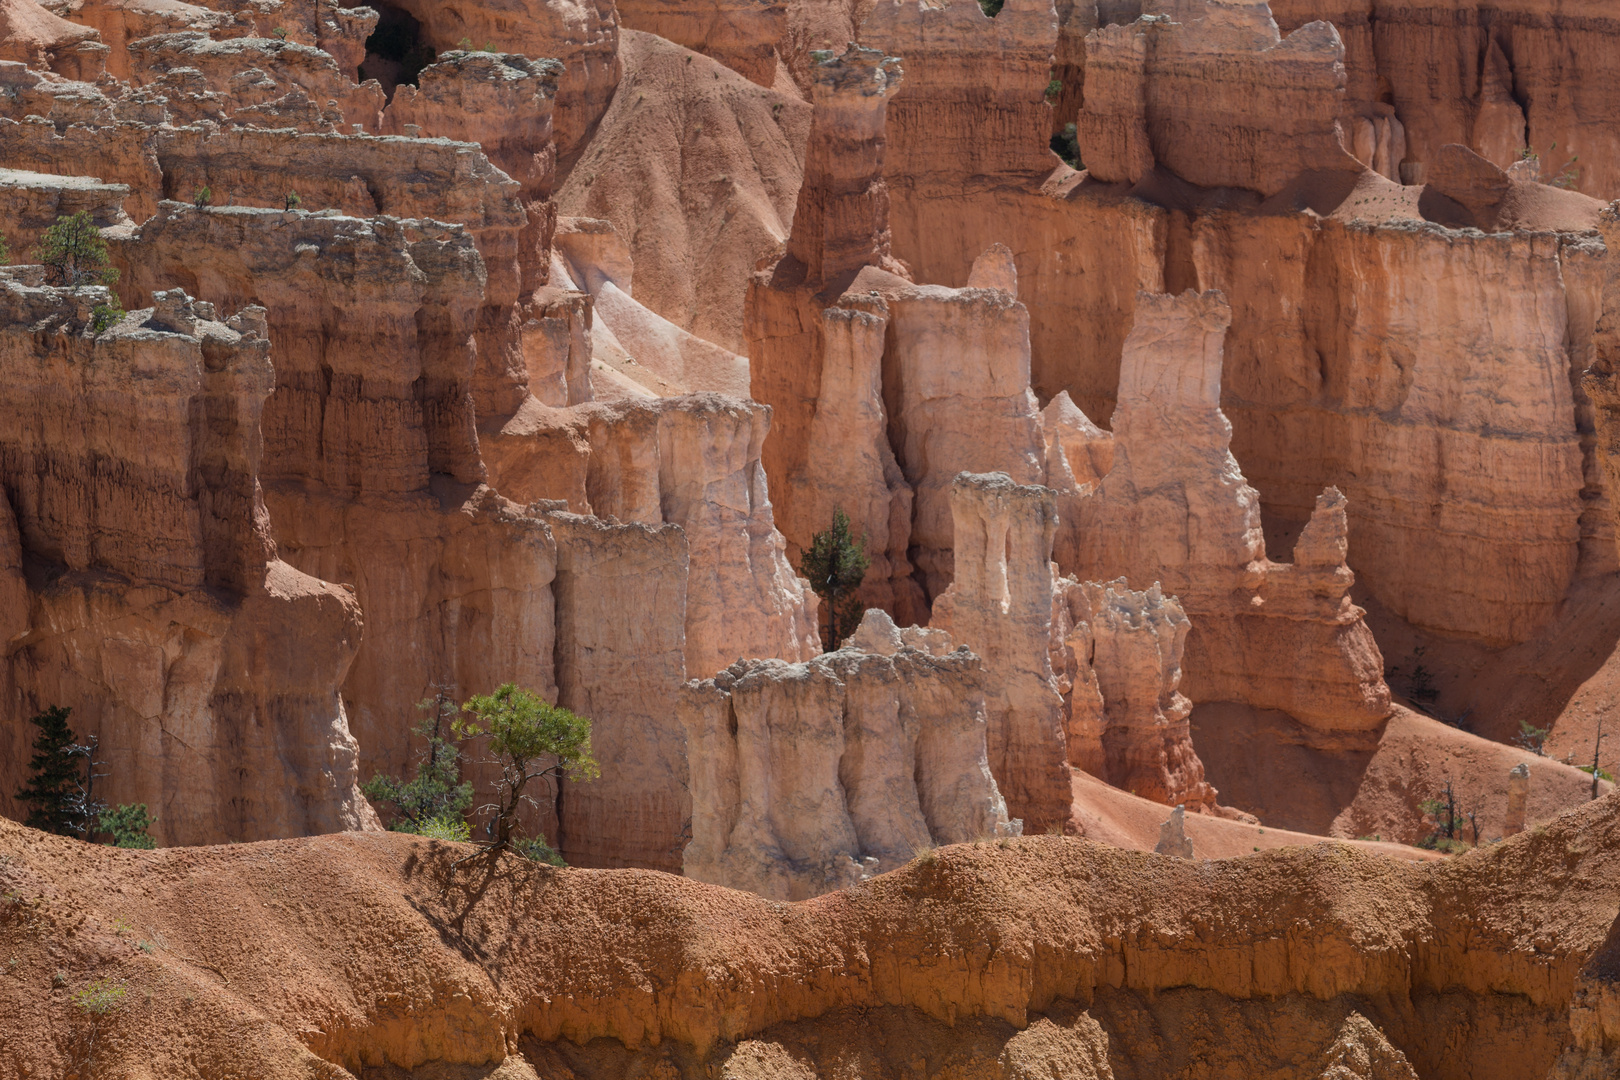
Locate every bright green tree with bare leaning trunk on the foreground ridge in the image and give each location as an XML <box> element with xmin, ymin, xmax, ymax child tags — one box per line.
<box><xmin>452</xmin><ymin>683</ymin><xmax>601</xmax><ymax>861</ymax></box>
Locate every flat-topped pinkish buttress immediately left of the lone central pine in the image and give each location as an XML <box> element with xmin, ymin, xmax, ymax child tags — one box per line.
<box><xmin>484</xmin><ymin>393</ymin><xmax>820</xmax><ymax>677</ymax></box>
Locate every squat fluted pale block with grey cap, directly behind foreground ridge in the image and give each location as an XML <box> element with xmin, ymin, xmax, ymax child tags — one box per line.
<box><xmin>679</xmin><ymin>644</ymin><xmax>1013</xmax><ymax>900</ymax></box>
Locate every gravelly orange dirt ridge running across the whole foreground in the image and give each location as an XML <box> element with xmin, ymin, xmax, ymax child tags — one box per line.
<box><xmin>0</xmin><ymin>797</ymin><xmax>1620</xmax><ymax>1080</ymax></box>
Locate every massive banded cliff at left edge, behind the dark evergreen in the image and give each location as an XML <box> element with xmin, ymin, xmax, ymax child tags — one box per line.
<box><xmin>0</xmin><ymin>276</ymin><xmax>377</xmax><ymax>844</ymax></box>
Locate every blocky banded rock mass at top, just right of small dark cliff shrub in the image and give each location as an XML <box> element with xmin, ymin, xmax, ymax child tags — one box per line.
<box><xmin>1077</xmin><ymin>0</ymin><xmax>1367</xmax><ymax>194</ymax></box>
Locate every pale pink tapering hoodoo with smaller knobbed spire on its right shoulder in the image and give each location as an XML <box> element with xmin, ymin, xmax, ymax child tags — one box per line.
<box><xmin>1064</xmin><ymin>291</ymin><xmax>1390</xmax><ymax>730</ymax></box>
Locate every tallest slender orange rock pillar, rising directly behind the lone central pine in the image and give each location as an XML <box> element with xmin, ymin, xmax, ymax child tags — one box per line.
<box><xmin>745</xmin><ymin>47</ymin><xmax>927</xmax><ymax>623</ymax></box>
